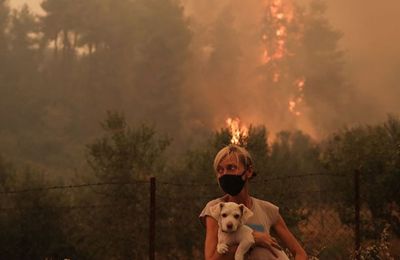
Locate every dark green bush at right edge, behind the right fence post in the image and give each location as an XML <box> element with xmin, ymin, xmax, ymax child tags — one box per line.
<box><xmin>322</xmin><ymin>116</ymin><xmax>400</xmax><ymax>236</ymax></box>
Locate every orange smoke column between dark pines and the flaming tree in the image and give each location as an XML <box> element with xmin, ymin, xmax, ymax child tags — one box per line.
<box><xmin>183</xmin><ymin>0</ymin><xmax>332</xmax><ymax>137</ymax></box>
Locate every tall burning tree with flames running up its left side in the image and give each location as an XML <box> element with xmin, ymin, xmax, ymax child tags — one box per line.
<box><xmin>260</xmin><ymin>0</ymin><xmax>356</xmax><ymax>135</ymax></box>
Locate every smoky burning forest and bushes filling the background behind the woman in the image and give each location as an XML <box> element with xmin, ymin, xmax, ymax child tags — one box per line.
<box><xmin>0</xmin><ymin>0</ymin><xmax>400</xmax><ymax>259</ymax></box>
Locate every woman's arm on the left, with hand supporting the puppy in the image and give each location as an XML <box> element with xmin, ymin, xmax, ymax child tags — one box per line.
<box><xmin>204</xmin><ymin>216</ymin><xmax>237</xmax><ymax>260</ymax></box>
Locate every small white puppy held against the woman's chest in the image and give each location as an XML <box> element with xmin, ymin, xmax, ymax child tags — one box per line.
<box><xmin>210</xmin><ymin>202</ymin><xmax>255</xmax><ymax>260</ymax></box>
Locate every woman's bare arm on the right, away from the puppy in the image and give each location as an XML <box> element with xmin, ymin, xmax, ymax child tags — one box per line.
<box><xmin>273</xmin><ymin>216</ymin><xmax>307</xmax><ymax>260</ymax></box>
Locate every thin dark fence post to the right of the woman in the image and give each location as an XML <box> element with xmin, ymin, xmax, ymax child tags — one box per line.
<box><xmin>354</xmin><ymin>169</ymin><xmax>361</xmax><ymax>260</ymax></box>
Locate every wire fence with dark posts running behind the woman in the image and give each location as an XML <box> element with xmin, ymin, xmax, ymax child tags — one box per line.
<box><xmin>0</xmin><ymin>173</ymin><xmax>396</xmax><ymax>260</ymax></box>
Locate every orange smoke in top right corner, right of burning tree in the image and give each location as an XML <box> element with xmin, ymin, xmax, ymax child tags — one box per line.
<box><xmin>318</xmin><ymin>0</ymin><xmax>400</xmax><ymax>122</ymax></box>
